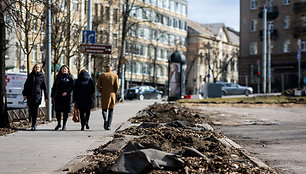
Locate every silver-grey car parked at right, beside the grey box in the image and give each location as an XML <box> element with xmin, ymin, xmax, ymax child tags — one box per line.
<box><xmin>219</xmin><ymin>82</ymin><xmax>253</xmax><ymax>96</ymax></box>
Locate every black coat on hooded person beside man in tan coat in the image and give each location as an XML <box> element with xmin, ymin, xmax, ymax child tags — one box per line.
<box><xmin>73</xmin><ymin>71</ymin><xmax>95</xmax><ymax>111</ymax></box>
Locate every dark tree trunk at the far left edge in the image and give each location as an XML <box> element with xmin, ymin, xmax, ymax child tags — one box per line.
<box><xmin>0</xmin><ymin>7</ymin><xmax>10</xmax><ymax>128</ymax></box>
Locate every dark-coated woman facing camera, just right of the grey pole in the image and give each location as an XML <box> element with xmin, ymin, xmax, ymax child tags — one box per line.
<box><xmin>51</xmin><ymin>65</ymin><xmax>74</xmax><ymax>130</ymax></box>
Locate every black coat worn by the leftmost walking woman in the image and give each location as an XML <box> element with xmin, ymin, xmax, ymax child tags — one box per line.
<box><xmin>22</xmin><ymin>72</ymin><xmax>48</xmax><ymax>106</ymax></box>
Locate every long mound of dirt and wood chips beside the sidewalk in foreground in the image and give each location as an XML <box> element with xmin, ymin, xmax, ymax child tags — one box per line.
<box><xmin>71</xmin><ymin>103</ymin><xmax>273</xmax><ymax>174</ymax></box>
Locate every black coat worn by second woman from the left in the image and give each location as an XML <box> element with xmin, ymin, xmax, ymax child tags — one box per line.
<box><xmin>51</xmin><ymin>74</ymin><xmax>74</xmax><ymax>113</ymax></box>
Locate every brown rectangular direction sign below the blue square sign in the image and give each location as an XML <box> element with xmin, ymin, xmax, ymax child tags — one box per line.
<box><xmin>81</xmin><ymin>44</ymin><xmax>112</xmax><ymax>55</ymax></box>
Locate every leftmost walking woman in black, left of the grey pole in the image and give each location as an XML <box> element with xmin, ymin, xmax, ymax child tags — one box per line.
<box><xmin>22</xmin><ymin>64</ymin><xmax>48</xmax><ymax>131</ymax></box>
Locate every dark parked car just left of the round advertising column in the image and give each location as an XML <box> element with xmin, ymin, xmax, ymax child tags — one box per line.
<box><xmin>126</xmin><ymin>86</ymin><xmax>163</xmax><ymax>100</ymax></box>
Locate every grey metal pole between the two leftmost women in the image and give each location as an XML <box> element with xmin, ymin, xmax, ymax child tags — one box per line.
<box><xmin>45</xmin><ymin>0</ymin><xmax>51</xmax><ymax>121</ymax></box>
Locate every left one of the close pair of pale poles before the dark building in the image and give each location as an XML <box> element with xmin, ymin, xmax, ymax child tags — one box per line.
<box><xmin>262</xmin><ymin>5</ymin><xmax>267</xmax><ymax>94</ymax></box>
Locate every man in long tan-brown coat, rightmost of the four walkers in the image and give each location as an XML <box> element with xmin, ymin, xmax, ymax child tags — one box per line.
<box><xmin>97</xmin><ymin>65</ymin><xmax>119</xmax><ymax>130</ymax></box>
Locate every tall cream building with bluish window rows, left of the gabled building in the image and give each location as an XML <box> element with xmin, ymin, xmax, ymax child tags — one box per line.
<box><xmin>120</xmin><ymin>0</ymin><xmax>187</xmax><ymax>92</ymax></box>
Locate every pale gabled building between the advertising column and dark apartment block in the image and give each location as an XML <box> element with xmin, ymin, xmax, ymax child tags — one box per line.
<box><xmin>186</xmin><ymin>20</ymin><xmax>239</xmax><ymax>94</ymax></box>
